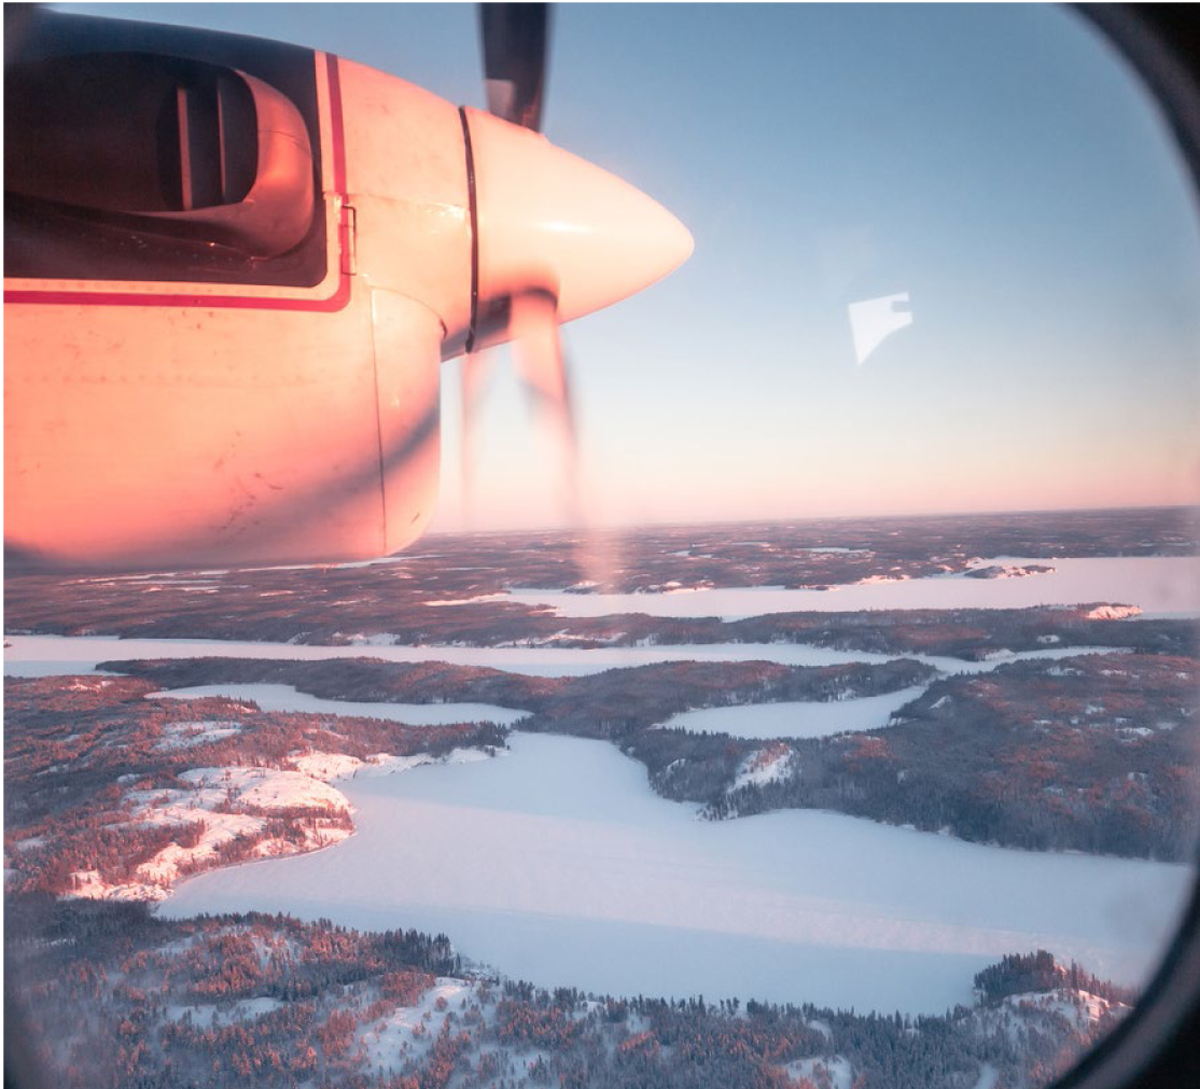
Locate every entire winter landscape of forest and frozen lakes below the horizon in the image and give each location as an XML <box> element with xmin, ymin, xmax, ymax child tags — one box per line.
<box><xmin>5</xmin><ymin>510</ymin><xmax>1200</xmax><ymax>1089</ymax></box>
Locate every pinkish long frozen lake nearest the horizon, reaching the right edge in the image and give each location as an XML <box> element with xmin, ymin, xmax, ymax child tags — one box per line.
<box><xmin>476</xmin><ymin>556</ymin><xmax>1200</xmax><ymax>620</ymax></box>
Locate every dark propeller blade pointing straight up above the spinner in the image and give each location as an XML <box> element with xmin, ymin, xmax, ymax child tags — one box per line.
<box><xmin>479</xmin><ymin>4</ymin><xmax>550</xmax><ymax>132</ymax></box>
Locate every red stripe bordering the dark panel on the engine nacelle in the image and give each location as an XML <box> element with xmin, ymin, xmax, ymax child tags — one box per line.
<box><xmin>4</xmin><ymin>53</ymin><xmax>350</xmax><ymax>313</ymax></box>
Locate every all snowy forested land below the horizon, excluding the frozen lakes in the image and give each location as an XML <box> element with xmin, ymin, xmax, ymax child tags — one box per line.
<box><xmin>4</xmin><ymin>510</ymin><xmax>1200</xmax><ymax>1089</ymax></box>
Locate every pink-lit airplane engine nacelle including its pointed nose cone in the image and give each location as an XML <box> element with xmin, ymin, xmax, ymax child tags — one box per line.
<box><xmin>4</xmin><ymin>13</ymin><xmax>691</xmax><ymax>568</ymax></box>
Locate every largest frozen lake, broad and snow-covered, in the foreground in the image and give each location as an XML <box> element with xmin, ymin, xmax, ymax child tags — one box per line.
<box><xmin>161</xmin><ymin>734</ymin><xmax>1192</xmax><ymax>1013</ymax></box>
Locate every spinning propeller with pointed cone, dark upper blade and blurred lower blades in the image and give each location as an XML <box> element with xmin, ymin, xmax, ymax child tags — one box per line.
<box><xmin>462</xmin><ymin>4</ymin><xmax>692</xmax><ymax>530</ymax></box>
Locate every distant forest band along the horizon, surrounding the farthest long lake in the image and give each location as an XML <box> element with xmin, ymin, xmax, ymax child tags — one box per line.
<box><xmin>5</xmin><ymin>509</ymin><xmax>1196</xmax><ymax>661</ymax></box>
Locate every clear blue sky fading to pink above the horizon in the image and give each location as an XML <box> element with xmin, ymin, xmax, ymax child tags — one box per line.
<box><xmin>56</xmin><ymin>4</ymin><xmax>1200</xmax><ymax>530</ymax></box>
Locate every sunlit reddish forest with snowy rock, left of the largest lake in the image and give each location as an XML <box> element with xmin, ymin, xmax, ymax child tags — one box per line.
<box><xmin>4</xmin><ymin>676</ymin><xmax>505</xmax><ymax>896</ymax></box>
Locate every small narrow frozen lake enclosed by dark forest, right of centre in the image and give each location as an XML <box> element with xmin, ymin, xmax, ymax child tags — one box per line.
<box><xmin>662</xmin><ymin>685</ymin><xmax>925</xmax><ymax>740</ymax></box>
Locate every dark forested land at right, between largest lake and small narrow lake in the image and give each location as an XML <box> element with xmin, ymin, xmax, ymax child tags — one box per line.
<box><xmin>622</xmin><ymin>655</ymin><xmax>1200</xmax><ymax>861</ymax></box>
